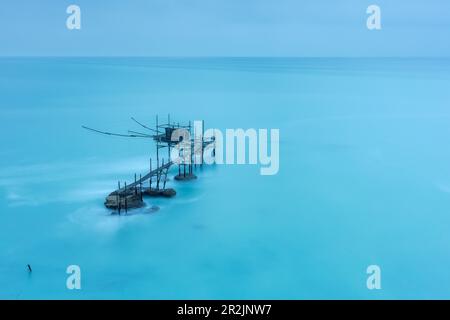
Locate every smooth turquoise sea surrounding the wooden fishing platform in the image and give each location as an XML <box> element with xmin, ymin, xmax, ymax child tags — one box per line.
<box><xmin>0</xmin><ymin>58</ymin><xmax>450</xmax><ymax>299</ymax></box>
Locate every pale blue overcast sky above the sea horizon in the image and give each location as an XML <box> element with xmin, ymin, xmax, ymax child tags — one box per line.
<box><xmin>0</xmin><ymin>0</ymin><xmax>450</xmax><ymax>57</ymax></box>
